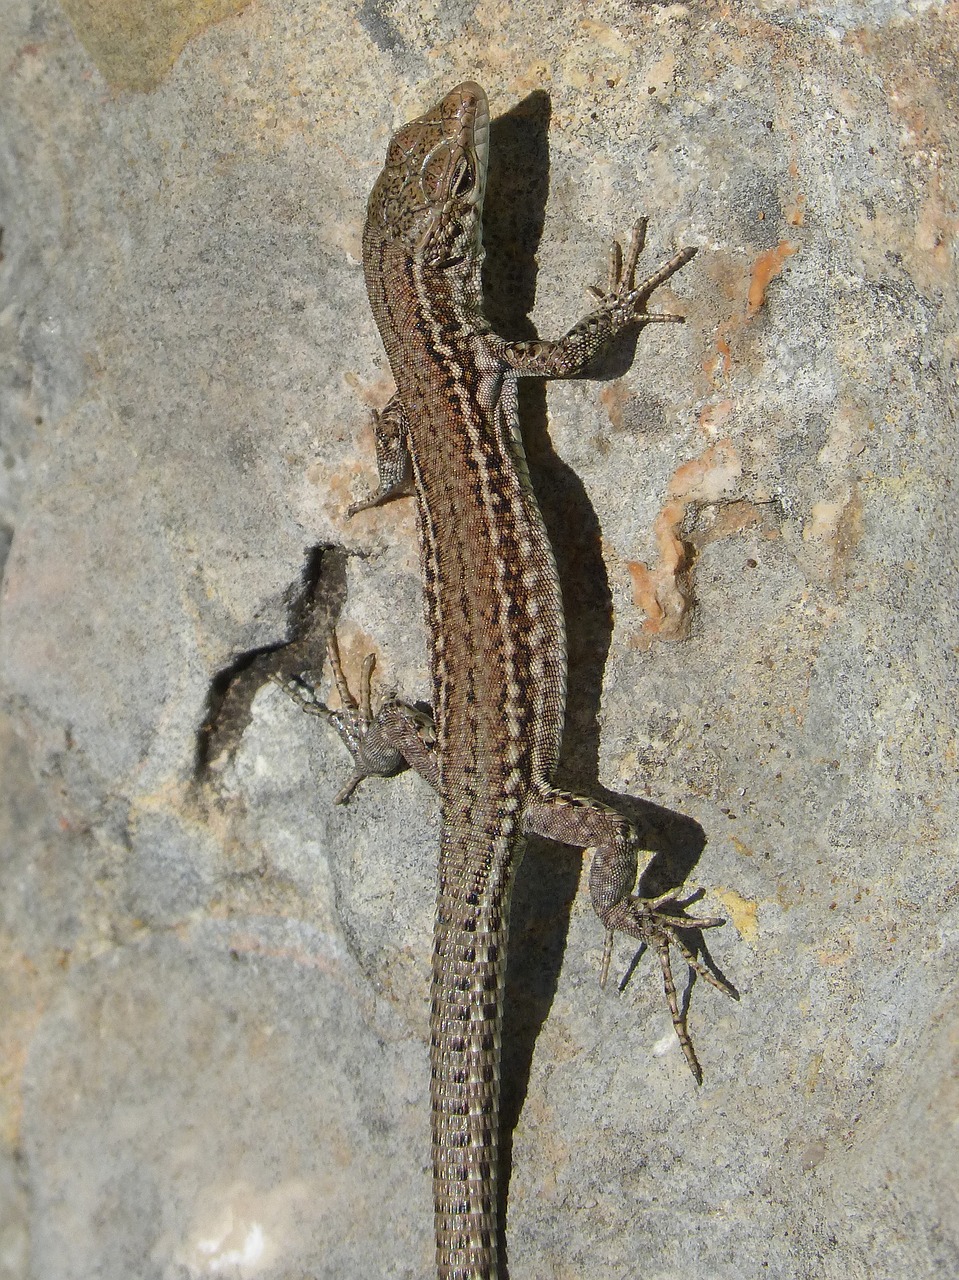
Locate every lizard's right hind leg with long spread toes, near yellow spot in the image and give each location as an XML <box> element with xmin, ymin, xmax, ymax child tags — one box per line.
<box><xmin>524</xmin><ymin>790</ymin><xmax>739</xmax><ymax>1084</ymax></box>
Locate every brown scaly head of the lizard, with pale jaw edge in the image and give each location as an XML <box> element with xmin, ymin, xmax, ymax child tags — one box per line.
<box><xmin>364</xmin><ymin>81</ymin><xmax>489</xmax><ymax>268</ymax></box>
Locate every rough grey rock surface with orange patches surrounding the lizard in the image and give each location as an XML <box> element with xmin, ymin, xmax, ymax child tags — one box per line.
<box><xmin>0</xmin><ymin>0</ymin><xmax>959</xmax><ymax>1280</ymax></box>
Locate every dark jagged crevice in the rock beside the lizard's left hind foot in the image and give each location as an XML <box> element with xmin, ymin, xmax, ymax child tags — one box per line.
<box><xmin>195</xmin><ymin>547</ymin><xmax>346</xmax><ymax>782</ymax></box>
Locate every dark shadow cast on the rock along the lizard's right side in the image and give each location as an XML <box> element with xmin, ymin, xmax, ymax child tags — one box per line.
<box><xmin>483</xmin><ymin>92</ymin><xmax>708</xmax><ymax>1274</ymax></box>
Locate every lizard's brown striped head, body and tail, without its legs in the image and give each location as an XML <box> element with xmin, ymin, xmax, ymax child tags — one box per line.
<box><xmin>364</xmin><ymin>83</ymin><xmax>566</xmax><ymax>1280</ymax></box>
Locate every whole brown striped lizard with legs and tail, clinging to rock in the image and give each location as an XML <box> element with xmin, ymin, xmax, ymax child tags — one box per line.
<box><xmin>289</xmin><ymin>82</ymin><xmax>735</xmax><ymax>1280</ymax></box>
